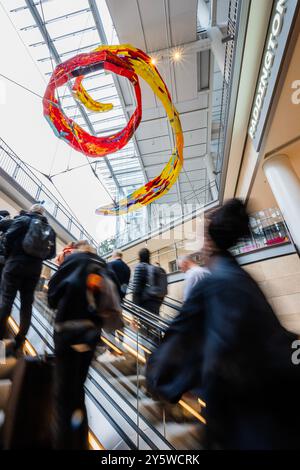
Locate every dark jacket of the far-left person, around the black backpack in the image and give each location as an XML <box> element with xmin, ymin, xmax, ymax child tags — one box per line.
<box><xmin>5</xmin><ymin>212</ymin><xmax>55</xmax><ymax>265</ymax></box>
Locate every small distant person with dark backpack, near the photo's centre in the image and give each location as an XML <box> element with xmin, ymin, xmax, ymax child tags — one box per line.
<box><xmin>133</xmin><ymin>248</ymin><xmax>167</xmax><ymax>315</ymax></box>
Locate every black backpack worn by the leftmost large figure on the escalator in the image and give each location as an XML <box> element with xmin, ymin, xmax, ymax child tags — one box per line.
<box><xmin>22</xmin><ymin>217</ymin><xmax>55</xmax><ymax>260</ymax></box>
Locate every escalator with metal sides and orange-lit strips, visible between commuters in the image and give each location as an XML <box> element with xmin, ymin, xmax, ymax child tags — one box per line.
<box><xmin>7</xmin><ymin>263</ymin><xmax>205</xmax><ymax>450</ymax></box>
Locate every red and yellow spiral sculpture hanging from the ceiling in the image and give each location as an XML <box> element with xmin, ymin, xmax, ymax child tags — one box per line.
<box><xmin>43</xmin><ymin>44</ymin><xmax>183</xmax><ymax>215</ymax></box>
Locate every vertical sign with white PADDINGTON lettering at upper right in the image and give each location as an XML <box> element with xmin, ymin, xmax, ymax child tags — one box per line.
<box><xmin>248</xmin><ymin>0</ymin><xmax>298</xmax><ymax>151</ymax></box>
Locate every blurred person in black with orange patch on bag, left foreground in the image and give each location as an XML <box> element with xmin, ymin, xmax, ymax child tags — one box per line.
<box><xmin>48</xmin><ymin>244</ymin><xmax>123</xmax><ymax>449</ymax></box>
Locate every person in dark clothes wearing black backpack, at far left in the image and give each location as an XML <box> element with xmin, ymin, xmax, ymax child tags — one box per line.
<box><xmin>0</xmin><ymin>204</ymin><xmax>56</xmax><ymax>349</ymax></box>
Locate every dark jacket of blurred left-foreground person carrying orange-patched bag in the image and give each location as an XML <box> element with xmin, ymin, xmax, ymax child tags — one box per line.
<box><xmin>48</xmin><ymin>252</ymin><xmax>106</xmax><ymax>322</ymax></box>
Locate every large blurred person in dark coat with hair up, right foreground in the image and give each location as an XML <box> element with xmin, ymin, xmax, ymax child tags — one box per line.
<box><xmin>146</xmin><ymin>199</ymin><xmax>300</xmax><ymax>449</ymax></box>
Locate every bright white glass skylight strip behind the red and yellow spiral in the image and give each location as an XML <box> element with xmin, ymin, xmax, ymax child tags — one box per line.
<box><xmin>9</xmin><ymin>0</ymin><xmax>144</xmax><ymax>199</ymax></box>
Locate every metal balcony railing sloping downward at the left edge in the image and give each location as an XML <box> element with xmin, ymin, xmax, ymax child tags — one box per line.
<box><xmin>0</xmin><ymin>138</ymin><xmax>98</xmax><ymax>247</ymax></box>
